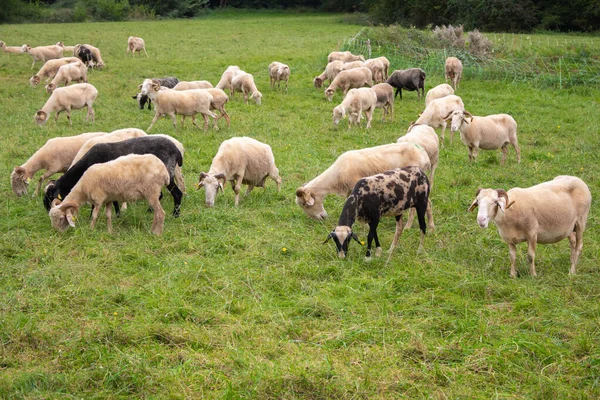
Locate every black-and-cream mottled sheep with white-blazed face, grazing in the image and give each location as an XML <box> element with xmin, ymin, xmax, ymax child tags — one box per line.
<box><xmin>324</xmin><ymin>167</ymin><xmax>431</xmax><ymax>260</ymax></box>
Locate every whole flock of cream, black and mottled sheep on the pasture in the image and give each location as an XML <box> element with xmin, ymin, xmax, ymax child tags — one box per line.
<box><xmin>0</xmin><ymin>37</ymin><xmax>591</xmax><ymax>277</ymax></box>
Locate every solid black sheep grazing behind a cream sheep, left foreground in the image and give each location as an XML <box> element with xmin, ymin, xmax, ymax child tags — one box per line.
<box><xmin>44</xmin><ymin>135</ymin><xmax>183</xmax><ymax>217</ymax></box>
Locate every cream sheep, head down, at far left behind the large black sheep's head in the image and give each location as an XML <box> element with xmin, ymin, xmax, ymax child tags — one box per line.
<box><xmin>10</xmin><ymin>132</ymin><xmax>106</xmax><ymax>197</ymax></box>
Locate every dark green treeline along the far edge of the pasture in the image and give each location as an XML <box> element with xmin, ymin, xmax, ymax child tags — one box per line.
<box><xmin>0</xmin><ymin>0</ymin><xmax>600</xmax><ymax>32</ymax></box>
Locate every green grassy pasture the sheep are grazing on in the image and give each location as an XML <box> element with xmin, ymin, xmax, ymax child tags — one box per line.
<box><xmin>0</xmin><ymin>13</ymin><xmax>600</xmax><ymax>399</ymax></box>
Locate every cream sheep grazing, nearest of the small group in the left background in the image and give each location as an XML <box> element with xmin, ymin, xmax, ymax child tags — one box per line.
<box><xmin>35</xmin><ymin>83</ymin><xmax>98</xmax><ymax>126</ymax></box>
